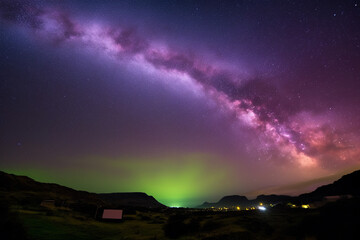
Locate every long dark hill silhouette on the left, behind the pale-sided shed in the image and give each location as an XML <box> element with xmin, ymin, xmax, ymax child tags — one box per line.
<box><xmin>0</xmin><ymin>171</ymin><xmax>165</xmax><ymax>208</ymax></box>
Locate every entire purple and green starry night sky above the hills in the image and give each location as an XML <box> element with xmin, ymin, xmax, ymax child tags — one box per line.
<box><xmin>0</xmin><ymin>0</ymin><xmax>360</xmax><ymax>206</ymax></box>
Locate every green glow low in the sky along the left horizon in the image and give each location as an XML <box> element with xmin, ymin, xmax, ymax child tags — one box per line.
<box><xmin>3</xmin><ymin>154</ymin><xmax>232</xmax><ymax>207</ymax></box>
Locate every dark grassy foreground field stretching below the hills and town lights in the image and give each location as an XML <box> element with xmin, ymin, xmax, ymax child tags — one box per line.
<box><xmin>1</xmin><ymin>199</ymin><xmax>360</xmax><ymax>240</ymax></box>
